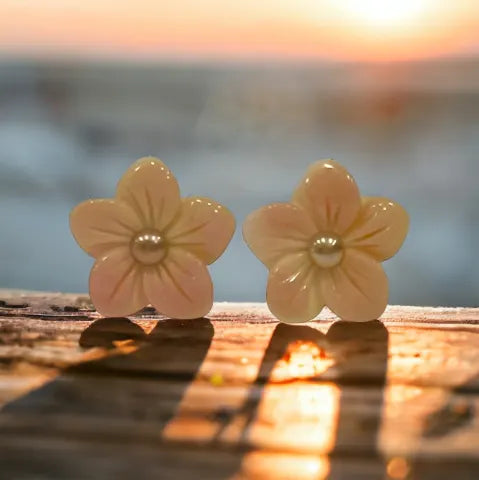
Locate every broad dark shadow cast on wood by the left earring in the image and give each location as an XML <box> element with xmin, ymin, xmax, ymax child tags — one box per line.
<box><xmin>0</xmin><ymin>318</ymin><xmax>214</xmax><ymax>479</ymax></box>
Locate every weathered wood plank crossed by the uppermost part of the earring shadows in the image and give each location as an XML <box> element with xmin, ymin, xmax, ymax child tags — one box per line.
<box><xmin>0</xmin><ymin>317</ymin><xmax>479</xmax><ymax>391</ymax></box>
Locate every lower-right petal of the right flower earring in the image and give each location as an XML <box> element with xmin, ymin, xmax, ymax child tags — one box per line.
<box><xmin>321</xmin><ymin>249</ymin><xmax>388</xmax><ymax>322</ymax></box>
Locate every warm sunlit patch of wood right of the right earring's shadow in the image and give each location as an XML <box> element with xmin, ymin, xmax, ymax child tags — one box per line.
<box><xmin>378</xmin><ymin>328</ymin><xmax>479</xmax><ymax>457</ymax></box>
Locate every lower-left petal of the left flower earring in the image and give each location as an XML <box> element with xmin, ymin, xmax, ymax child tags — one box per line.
<box><xmin>90</xmin><ymin>247</ymin><xmax>148</xmax><ymax>317</ymax></box>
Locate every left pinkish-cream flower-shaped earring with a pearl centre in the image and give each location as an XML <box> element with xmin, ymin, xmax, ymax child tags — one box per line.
<box><xmin>70</xmin><ymin>157</ymin><xmax>235</xmax><ymax>319</ymax></box>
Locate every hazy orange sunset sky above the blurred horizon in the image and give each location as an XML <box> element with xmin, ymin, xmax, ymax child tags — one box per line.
<box><xmin>0</xmin><ymin>0</ymin><xmax>479</xmax><ymax>60</ymax></box>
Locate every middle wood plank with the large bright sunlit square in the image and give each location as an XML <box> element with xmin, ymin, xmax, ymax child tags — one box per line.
<box><xmin>0</xmin><ymin>376</ymin><xmax>479</xmax><ymax>459</ymax></box>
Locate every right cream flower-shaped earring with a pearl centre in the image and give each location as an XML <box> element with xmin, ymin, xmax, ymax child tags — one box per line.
<box><xmin>243</xmin><ymin>160</ymin><xmax>409</xmax><ymax>323</ymax></box>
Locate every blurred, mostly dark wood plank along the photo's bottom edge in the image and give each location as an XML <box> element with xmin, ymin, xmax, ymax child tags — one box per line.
<box><xmin>0</xmin><ymin>437</ymin><xmax>479</xmax><ymax>480</ymax></box>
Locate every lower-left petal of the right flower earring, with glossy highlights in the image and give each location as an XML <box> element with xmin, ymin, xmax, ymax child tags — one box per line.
<box><xmin>266</xmin><ymin>252</ymin><xmax>323</xmax><ymax>323</ymax></box>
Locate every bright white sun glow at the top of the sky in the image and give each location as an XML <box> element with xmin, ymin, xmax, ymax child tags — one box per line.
<box><xmin>338</xmin><ymin>0</ymin><xmax>430</xmax><ymax>27</ymax></box>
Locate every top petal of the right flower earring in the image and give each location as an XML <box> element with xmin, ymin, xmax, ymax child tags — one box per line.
<box><xmin>292</xmin><ymin>160</ymin><xmax>361</xmax><ymax>234</ymax></box>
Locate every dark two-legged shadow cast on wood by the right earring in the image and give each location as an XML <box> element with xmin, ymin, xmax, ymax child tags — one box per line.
<box><xmin>229</xmin><ymin>320</ymin><xmax>389</xmax><ymax>480</ymax></box>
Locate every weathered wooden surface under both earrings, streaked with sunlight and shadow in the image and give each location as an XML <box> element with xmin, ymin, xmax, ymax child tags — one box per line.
<box><xmin>0</xmin><ymin>291</ymin><xmax>479</xmax><ymax>480</ymax></box>
